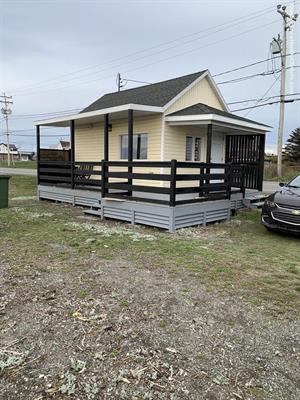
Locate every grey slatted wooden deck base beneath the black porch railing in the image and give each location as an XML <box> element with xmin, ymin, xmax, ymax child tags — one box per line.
<box><xmin>38</xmin><ymin>185</ymin><xmax>243</xmax><ymax>232</ymax></box>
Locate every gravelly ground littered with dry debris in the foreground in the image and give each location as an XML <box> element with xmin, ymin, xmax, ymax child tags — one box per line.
<box><xmin>0</xmin><ymin>252</ymin><xmax>300</xmax><ymax>400</ymax></box>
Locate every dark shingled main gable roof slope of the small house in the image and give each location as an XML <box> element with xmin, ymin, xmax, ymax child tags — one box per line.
<box><xmin>81</xmin><ymin>70</ymin><xmax>207</xmax><ymax>113</ymax></box>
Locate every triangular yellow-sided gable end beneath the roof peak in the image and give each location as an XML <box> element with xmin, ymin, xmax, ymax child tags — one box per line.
<box><xmin>166</xmin><ymin>78</ymin><xmax>225</xmax><ymax>114</ymax></box>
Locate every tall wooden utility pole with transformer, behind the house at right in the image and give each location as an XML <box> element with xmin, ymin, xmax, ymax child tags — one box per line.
<box><xmin>273</xmin><ymin>4</ymin><xmax>298</xmax><ymax>177</ymax></box>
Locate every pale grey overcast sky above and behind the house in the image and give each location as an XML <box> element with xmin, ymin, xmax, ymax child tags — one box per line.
<box><xmin>0</xmin><ymin>0</ymin><xmax>300</xmax><ymax>151</ymax></box>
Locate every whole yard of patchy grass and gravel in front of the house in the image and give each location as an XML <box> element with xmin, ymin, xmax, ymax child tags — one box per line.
<box><xmin>0</xmin><ymin>177</ymin><xmax>300</xmax><ymax>399</ymax></box>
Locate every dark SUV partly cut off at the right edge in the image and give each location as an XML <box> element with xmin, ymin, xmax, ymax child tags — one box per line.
<box><xmin>261</xmin><ymin>175</ymin><xmax>300</xmax><ymax>234</ymax></box>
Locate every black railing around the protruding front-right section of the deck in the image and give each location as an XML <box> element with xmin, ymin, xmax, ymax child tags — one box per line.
<box><xmin>102</xmin><ymin>160</ymin><xmax>245</xmax><ymax>207</ymax></box>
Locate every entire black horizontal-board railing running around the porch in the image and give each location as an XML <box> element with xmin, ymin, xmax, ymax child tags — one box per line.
<box><xmin>38</xmin><ymin>160</ymin><xmax>245</xmax><ymax>207</ymax></box>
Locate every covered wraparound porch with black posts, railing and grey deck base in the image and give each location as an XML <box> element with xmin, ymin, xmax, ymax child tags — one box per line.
<box><xmin>36</xmin><ymin>104</ymin><xmax>264</xmax><ymax>231</ymax></box>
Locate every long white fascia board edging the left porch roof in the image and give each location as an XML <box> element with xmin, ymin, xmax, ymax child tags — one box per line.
<box><xmin>34</xmin><ymin>104</ymin><xmax>163</xmax><ymax>125</ymax></box>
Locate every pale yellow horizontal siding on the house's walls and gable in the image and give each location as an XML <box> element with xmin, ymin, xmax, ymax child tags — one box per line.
<box><xmin>75</xmin><ymin>78</ymin><xmax>224</xmax><ymax>186</ymax></box>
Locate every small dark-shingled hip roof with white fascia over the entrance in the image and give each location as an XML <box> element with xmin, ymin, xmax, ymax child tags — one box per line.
<box><xmin>166</xmin><ymin>103</ymin><xmax>272</xmax><ymax>132</ymax></box>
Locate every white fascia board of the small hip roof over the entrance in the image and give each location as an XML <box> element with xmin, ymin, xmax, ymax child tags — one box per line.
<box><xmin>166</xmin><ymin>114</ymin><xmax>272</xmax><ymax>132</ymax></box>
